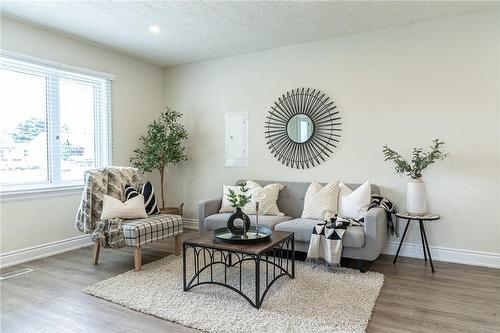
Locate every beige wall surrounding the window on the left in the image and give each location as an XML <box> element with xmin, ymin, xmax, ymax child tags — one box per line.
<box><xmin>0</xmin><ymin>17</ymin><xmax>165</xmax><ymax>253</ymax></box>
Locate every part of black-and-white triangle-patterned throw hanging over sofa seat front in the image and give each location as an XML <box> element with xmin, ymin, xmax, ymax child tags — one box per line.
<box><xmin>307</xmin><ymin>216</ymin><xmax>363</xmax><ymax>266</ymax></box>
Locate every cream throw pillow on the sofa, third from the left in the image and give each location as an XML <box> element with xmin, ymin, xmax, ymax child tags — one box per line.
<box><xmin>302</xmin><ymin>180</ymin><xmax>339</xmax><ymax>220</ymax></box>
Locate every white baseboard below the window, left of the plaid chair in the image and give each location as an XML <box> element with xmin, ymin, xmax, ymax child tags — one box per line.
<box><xmin>0</xmin><ymin>235</ymin><xmax>92</xmax><ymax>268</ymax></box>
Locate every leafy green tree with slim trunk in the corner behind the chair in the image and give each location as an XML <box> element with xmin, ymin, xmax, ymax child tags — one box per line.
<box><xmin>130</xmin><ymin>107</ymin><xmax>188</xmax><ymax>208</ymax></box>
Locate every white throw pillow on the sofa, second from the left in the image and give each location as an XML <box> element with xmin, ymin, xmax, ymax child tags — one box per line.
<box><xmin>243</xmin><ymin>180</ymin><xmax>285</xmax><ymax>216</ymax></box>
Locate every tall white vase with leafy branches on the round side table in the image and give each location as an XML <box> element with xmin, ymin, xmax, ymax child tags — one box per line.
<box><xmin>383</xmin><ymin>139</ymin><xmax>448</xmax><ymax>216</ymax></box>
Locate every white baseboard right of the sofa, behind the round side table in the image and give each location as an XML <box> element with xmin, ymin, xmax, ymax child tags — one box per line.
<box><xmin>382</xmin><ymin>241</ymin><xmax>500</xmax><ymax>268</ymax></box>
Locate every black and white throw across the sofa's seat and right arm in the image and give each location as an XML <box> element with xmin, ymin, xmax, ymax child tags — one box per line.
<box><xmin>307</xmin><ymin>195</ymin><xmax>397</xmax><ymax>266</ymax></box>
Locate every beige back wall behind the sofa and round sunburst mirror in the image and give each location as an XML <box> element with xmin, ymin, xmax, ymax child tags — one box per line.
<box><xmin>166</xmin><ymin>12</ymin><xmax>500</xmax><ymax>254</ymax></box>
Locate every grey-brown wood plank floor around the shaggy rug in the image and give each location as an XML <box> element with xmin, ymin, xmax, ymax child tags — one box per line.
<box><xmin>0</xmin><ymin>232</ymin><xmax>500</xmax><ymax>333</ymax></box>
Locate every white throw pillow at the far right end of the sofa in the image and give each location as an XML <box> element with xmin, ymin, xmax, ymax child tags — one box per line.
<box><xmin>339</xmin><ymin>181</ymin><xmax>372</xmax><ymax>220</ymax></box>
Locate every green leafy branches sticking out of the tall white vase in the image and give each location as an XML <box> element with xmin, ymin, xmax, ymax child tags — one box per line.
<box><xmin>383</xmin><ymin>139</ymin><xmax>448</xmax><ymax>179</ymax></box>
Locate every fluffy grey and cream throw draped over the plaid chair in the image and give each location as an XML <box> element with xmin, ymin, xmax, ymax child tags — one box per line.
<box><xmin>75</xmin><ymin>167</ymin><xmax>140</xmax><ymax>247</ymax></box>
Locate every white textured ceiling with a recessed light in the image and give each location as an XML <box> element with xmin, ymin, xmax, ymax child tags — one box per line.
<box><xmin>1</xmin><ymin>1</ymin><xmax>500</xmax><ymax>66</ymax></box>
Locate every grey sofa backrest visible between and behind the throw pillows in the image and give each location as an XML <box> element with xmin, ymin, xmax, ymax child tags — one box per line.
<box><xmin>236</xmin><ymin>180</ymin><xmax>380</xmax><ymax>217</ymax></box>
